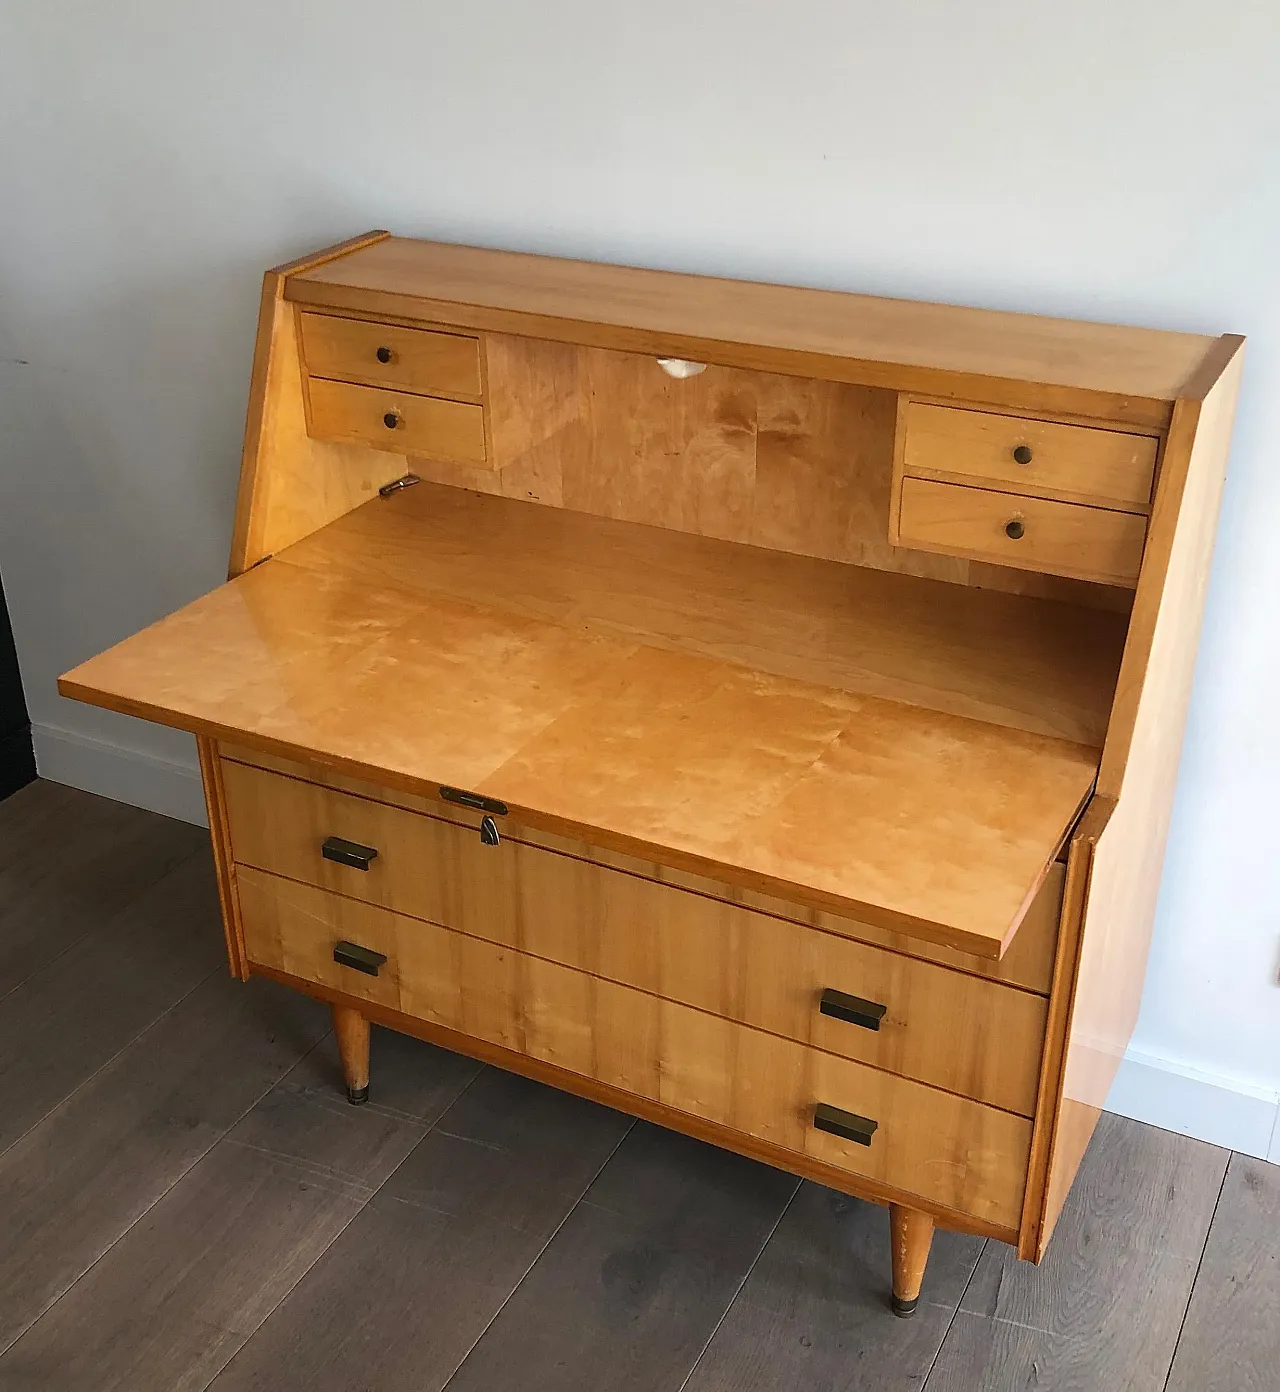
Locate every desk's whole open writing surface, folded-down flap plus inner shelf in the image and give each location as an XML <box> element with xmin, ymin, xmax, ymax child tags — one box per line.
<box><xmin>60</xmin><ymin>483</ymin><xmax>1124</xmax><ymax>956</ymax></box>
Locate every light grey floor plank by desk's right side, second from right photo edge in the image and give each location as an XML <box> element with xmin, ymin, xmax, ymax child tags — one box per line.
<box><xmin>925</xmin><ymin>1114</ymin><xmax>1229</xmax><ymax>1392</ymax></box>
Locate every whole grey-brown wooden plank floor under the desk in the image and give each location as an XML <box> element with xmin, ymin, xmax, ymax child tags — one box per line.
<box><xmin>0</xmin><ymin>782</ymin><xmax>1280</xmax><ymax>1392</ymax></box>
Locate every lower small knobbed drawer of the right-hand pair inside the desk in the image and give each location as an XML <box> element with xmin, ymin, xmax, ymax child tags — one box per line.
<box><xmin>899</xmin><ymin>479</ymin><xmax>1146</xmax><ymax>585</ymax></box>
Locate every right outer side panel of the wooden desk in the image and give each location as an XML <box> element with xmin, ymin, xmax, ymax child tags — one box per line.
<box><xmin>1037</xmin><ymin>347</ymin><xmax>1242</xmax><ymax>1256</ymax></box>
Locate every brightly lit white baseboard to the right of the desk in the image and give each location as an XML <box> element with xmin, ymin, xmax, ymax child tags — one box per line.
<box><xmin>1106</xmin><ymin>1048</ymin><xmax>1280</xmax><ymax>1164</ymax></box>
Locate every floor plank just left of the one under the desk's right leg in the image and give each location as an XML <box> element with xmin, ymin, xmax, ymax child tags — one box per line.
<box><xmin>448</xmin><ymin>1122</ymin><xmax>797</xmax><ymax>1392</ymax></box>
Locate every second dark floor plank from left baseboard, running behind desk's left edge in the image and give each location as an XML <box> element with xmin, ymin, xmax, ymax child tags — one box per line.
<box><xmin>0</xmin><ymin>852</ymin><xmax>225</xmax><ymax>1150</ymax></box>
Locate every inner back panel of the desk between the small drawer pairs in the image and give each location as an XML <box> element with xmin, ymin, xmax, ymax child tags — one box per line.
<box><xmin>406</xmin><ymin>330</ymin><xmax>1129</xmax><ymax>610</ymax></box>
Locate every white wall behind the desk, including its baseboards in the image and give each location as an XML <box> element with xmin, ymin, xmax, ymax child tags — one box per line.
<box><xmin>0</xmin><ymin>0</ymin><xmax>1280</xmax><ymax>1158</ymax></box>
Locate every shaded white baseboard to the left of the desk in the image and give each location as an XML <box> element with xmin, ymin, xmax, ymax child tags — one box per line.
<box><xmin>31</xmin><ymin>725</ymin><xmax>209</xmax><ymax>827</ymax></box>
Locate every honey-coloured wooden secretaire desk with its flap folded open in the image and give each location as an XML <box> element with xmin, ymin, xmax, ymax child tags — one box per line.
<box><xmin>60</xmin><ymin>232</ymin><xmax>1241</xmax><ymax>1313</ymax></box>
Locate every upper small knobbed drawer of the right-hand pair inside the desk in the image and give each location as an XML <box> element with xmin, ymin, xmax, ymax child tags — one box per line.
<box><xmin>903</xmin><ymin>401</ymin><xmax>1156</xmax><ymax>512</ymax></box>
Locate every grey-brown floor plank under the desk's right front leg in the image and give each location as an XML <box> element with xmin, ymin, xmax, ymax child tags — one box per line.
<box><xmin>687</xmin><ymin>1183</ymin><xmax>984</xmax><ymax>1392</ymax></box>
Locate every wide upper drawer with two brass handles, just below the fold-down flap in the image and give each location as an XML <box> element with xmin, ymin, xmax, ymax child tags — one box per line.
<box><xmin>223</xmin><ymin>763</ymin><xmax>1046</xmax><ymax>1116</ymax></box>
